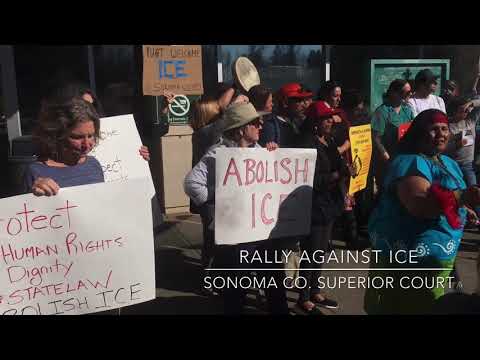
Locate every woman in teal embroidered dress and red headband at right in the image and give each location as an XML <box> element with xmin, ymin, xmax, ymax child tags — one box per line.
<box><xmin>365</xmin><ymin>109</ymin><xmax>480</xmax><ymax>314</ymax></box>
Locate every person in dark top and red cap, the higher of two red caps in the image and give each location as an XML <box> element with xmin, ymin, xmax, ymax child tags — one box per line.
<box><xmin>259</xmin><ymin>83</ymin><xmax>313</xmax><ymax>148</ymax></box>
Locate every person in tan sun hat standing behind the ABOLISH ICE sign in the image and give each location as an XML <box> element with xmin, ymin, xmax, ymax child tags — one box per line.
<box><xmin>184</xmin><ymin>103</ymin><xmax>288</xmax><ymax>315</ymax></box>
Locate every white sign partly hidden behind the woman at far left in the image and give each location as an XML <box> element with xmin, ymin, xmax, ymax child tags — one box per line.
<box><xmin>90</xmin><ymin>114</ymin><xmax>155</xmax><ymax>198</ymax></box>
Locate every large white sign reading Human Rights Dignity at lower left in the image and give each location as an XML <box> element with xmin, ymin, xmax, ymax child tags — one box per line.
<box><xmin>0</xmin><ymin>179</ymin><xmax>155</xmax><ymax>315</ymax></box>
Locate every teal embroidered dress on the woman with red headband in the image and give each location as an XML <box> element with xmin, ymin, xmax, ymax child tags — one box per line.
<box><xmin>365</xmin><ymin>154</ymin><xmax>466</xmax><ymax>314</ymax></box>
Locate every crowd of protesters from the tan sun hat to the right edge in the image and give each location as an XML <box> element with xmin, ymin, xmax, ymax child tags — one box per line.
<box><xmin>184</xmin><ymin>64</ymin><xmax>480</xmax><ymax>314</ymax></box>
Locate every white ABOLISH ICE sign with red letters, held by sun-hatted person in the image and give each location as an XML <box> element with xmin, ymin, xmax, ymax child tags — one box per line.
<box><xmin>215</xmin><ymin>148</ymin><xmax>317</xmax><ymax>245</ymax></box>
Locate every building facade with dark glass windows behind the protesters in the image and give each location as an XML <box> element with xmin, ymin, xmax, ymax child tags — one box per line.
<box><xmin>0</xmin><ymin>45</ymin><xmax>480</xmax><ymax>213</ymax></box>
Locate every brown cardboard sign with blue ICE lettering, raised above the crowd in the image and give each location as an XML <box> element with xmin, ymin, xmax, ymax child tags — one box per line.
<box><xmin>143</xmin><ymin>45</ymin><xmax>203</xmax><ymax>96</ymax></box>
